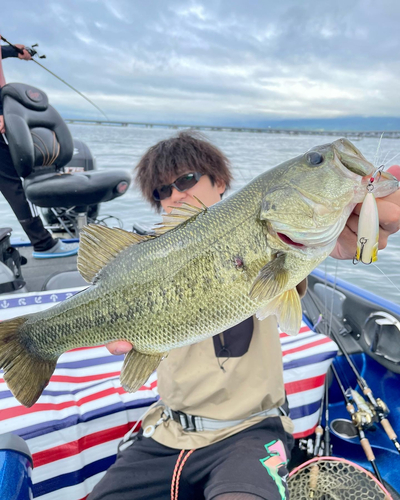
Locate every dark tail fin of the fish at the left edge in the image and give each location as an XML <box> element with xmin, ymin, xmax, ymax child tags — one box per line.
<box><xmin>0</xmin><ymin>316</ymin><xmax>57</xmax><ymax>408</ymax></box>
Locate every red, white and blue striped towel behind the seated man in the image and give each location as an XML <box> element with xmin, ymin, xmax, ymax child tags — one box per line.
<box><xmin>0</xmin><ymin>290</ymin><xmax>337</xmax><ymax>500</ymax></box>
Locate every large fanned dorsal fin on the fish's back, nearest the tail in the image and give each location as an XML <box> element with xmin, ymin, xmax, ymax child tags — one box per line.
<box><xmin>78</xmin><ymin>224</ymin><xmax>153</xmax><ymax>283</ymax></box>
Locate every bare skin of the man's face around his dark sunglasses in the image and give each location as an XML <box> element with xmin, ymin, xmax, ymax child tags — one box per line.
<box><xmin>160</xmin><ymin>175</ymin><xmax>226</xmax><ymax>213</ymax></box>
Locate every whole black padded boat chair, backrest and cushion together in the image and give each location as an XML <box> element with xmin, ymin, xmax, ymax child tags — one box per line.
<box><xmin>1</xmin><ymin>83</ymin><xmax>131</xmax><ymax>237</ymax></box>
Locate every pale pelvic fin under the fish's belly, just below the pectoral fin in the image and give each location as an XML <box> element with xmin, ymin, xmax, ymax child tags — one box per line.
<box><xmin>256</xmin><ymin>288</ymin><xmax>302</xmax><ymax>335</ymax></box>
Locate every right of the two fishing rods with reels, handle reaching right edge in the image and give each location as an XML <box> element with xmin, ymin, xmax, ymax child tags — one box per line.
<box><xmin>303</xmin><ymin>290</ymin><xmax>400</xmax><ymax>453</ymax></box>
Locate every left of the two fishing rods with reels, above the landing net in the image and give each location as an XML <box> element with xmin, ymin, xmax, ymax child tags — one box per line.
<box><xmin>331</xmin><ymin>363</ymin><xmax>383</xmax><ymax>484</ymax></box>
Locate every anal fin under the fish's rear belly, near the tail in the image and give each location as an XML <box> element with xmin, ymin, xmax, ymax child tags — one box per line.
<box><xmin>120</xmin><ymin>349</ymin><xmax>166</xmax><ymax>392</ymax></box>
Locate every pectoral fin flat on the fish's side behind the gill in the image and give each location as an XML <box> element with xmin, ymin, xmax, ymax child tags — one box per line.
<box><xmin>250</xmin><ymin>253</ymin><xmax>289</xmax><ymax>301</ymax></box>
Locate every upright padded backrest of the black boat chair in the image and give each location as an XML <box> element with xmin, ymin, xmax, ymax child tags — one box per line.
<box><xmin>1</xmin><ymin>83</ymin><xmax>74</xmax><ymax>177</ymax></box>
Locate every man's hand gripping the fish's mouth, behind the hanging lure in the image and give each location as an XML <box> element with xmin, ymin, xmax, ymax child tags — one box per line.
<box><xmin>331</xmin><ymin>165</ymin><xmax>400</xmax><ymax>259</ymax></box>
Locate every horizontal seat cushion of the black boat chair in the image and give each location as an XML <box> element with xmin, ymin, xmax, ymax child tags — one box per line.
<box><xmin>24</xmin><ymin>169</ymin><xmax>131</xmax><ymax>208</ymax></box>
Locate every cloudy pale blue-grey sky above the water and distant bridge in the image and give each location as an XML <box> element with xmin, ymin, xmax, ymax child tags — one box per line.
<box><xmin>0</xmin><ymin>0</ymin><xmax>400</xmax><ymax>126</ymax></box>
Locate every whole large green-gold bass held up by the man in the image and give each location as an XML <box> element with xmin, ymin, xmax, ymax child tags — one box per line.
<box><xmin>0</xmin><ymin>139</ymin><xmax>398</xmax><ymax>407</ymax></box>
